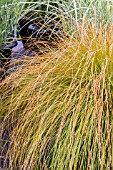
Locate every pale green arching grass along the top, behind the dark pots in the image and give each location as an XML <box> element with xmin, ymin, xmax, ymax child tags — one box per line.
<box><xmin>0</xmin><ymin>0</ymin><xmax>113</xmax><ymax>43</ymax></box>
